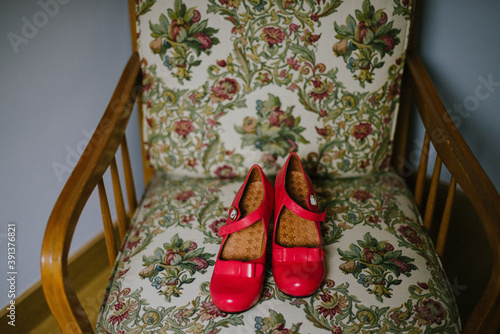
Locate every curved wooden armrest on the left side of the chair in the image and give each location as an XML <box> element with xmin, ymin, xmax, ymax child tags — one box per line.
<box><xmin>40</xmin><ymin>53</ymin><xmax>142</xmax><ymax>333</ymax></box>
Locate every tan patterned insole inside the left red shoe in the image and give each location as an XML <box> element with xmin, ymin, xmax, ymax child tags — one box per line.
<box><xmin>221</xmin><ymin>173</ymin><xmax>266</xmax><ymax>261</ymax></box>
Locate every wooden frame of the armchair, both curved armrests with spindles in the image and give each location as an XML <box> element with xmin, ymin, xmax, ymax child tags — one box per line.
<box><xmin>41</xmin><ymin>1</ymin><xmax>500</xmax><ymax>333</ymax></box>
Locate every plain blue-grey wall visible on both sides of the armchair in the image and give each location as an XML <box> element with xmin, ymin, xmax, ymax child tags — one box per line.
<box><xmin>0</xmin><ymin>0</ymin><xmax>500</xmax><ymax>307</ymax></box>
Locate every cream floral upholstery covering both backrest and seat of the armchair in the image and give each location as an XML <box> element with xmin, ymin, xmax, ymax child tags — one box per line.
<box><xmin>97</xmin><ymin>0</ymin><xmax>460</xmax><ymax>334</ymax></box>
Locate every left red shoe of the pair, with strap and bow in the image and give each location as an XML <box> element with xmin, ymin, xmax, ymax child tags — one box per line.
<box><xmin>210</xmin><ymin>165</ymin><xmax>274</xmax><ymax>313</ymax></box>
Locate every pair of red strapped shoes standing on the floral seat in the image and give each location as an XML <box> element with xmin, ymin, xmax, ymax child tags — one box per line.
<box><xmin>210</xmin><ymin>153</ymin><xmax>325</xmax><ymax>312</ymax></box>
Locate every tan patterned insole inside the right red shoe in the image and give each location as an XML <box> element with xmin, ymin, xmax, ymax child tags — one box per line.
<box><xmin>275</xmin><ymin>168</ymin><xmax>320</xmax><ymax>248</ymax></box>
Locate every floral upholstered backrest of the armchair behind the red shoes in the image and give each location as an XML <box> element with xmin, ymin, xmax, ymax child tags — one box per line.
<box><xmin>135</xmin><ymin>0</ymin><xmax>413</xmax><ymax>178</ymax></box>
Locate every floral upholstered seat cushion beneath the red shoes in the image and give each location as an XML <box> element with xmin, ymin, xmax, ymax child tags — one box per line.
<box><xmin>97</xmin><ymin>171</ymin><xmax>460</xmax><ymax>334</ymax></box>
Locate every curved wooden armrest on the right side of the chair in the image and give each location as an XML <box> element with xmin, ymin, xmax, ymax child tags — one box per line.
<box><xmin>406</xmin><ymin>54</ymin><xmax>500</xmax><ymax>333</ymax></box>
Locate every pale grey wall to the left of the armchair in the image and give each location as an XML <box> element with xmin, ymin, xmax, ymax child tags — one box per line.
<box><xmin>0</xmin><ymin>0</ymin><xmax>143</xmax><ymax>307</ymax></box>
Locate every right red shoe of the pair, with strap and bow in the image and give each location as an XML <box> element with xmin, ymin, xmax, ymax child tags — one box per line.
<box><xmin>273</xmin><ymin>153</ymin><xmax>326</xmax><ymax>297</ymax></box>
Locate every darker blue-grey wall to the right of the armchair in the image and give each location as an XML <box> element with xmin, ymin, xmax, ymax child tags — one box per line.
<box><xmin>408</xmin><ymin>0</ymin><xmax>500</xmax><ymax>190</ymax></box>
